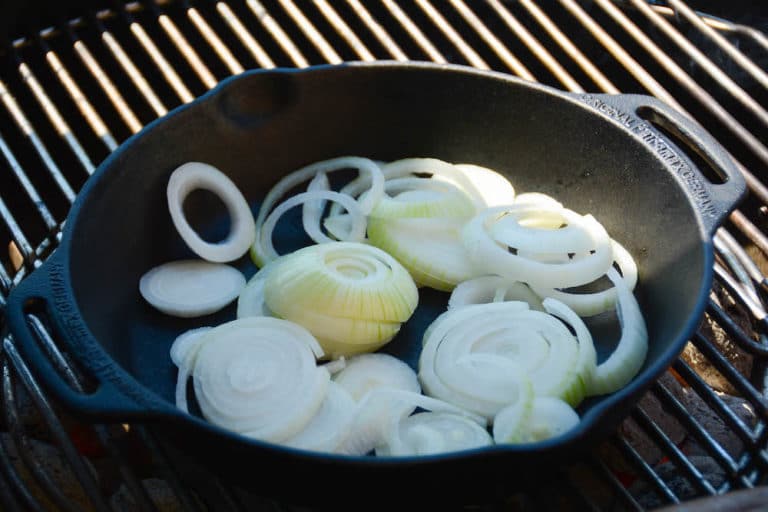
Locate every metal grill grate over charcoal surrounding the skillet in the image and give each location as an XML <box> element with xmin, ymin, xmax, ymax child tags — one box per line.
<box><xmin>0</xmin><ymin>0</ymin><xmax>768</xmax><ymax>511</ymax></box>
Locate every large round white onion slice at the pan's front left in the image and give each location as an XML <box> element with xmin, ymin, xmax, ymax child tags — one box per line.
<box><xmin>187</xmin><ymin>317</ymin><xmax>330</xmax><ymax>442</ymax></box>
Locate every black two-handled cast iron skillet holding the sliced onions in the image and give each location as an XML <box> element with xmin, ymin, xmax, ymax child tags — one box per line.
<box><xmin>8</xmin><ymin>62</ymin><xmax>745</xmax><ymax>506</ymax></box>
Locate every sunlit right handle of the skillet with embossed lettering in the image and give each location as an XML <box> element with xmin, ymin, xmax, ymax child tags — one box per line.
<box><xmin>576</xmin><ymin>94</ymin><xmax>747</xmax><ymax>235</ymax></box>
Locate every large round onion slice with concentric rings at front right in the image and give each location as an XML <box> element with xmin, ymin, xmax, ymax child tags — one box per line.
<box><xmin>419</xmin><ymin>302</ymin><xmax>591</xmax><ymax>419</ymax></box>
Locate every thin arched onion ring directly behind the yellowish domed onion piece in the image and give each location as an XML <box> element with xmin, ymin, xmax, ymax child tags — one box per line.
<box><xmin>251</xmin><ymin>190</ymin><xmax>366</xmax><ymax>266</ymax></box>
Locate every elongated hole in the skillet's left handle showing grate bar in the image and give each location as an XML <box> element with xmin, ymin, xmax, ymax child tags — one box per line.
<box><xmin>24</xmin><ymin>298</ymin><xmax>98</xmax><ymax>394</ymax></box>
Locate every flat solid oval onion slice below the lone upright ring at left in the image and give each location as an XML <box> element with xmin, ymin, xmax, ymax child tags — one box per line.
<box><xmin>139</xmin><ymin>260</ymin><xmax>245</xmax><ymax>318</ymax></box>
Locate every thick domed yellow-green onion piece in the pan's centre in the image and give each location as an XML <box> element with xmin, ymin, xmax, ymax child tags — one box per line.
<box><xmin>265</xmin><ymin>242</ymin><xmax>419</xmax><ymax>358</ymax></box>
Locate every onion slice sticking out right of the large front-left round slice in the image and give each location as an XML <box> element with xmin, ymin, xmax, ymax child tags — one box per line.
<box><xmin>281</xmin><ymin>382</ymin><xmax>357</xmax><ymax>453</ymax></box>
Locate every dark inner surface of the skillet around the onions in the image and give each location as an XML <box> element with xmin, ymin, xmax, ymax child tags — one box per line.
<box><xmin>69</xmin><ymin>66</ymin><xmax>708</xmax><ymax>448</ymax></box>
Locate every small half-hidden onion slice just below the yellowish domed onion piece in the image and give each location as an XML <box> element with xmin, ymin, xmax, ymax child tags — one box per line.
<box><xmin>333</xmin><ymin>352</ymin><xmax>421</xmax><ymax>401</ymax></box>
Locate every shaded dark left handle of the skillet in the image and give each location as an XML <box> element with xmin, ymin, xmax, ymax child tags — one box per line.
<box><xmin>6</xmin><ymin>250</ymin><xmax>173</xmax><ymax>422</ymax></box>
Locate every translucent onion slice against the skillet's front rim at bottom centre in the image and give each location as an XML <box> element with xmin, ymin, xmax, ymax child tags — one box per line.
<box><xmin>376</xmin><ymin>412</ymin><xmax>493</xmax><ymax>456</ymax></box>
